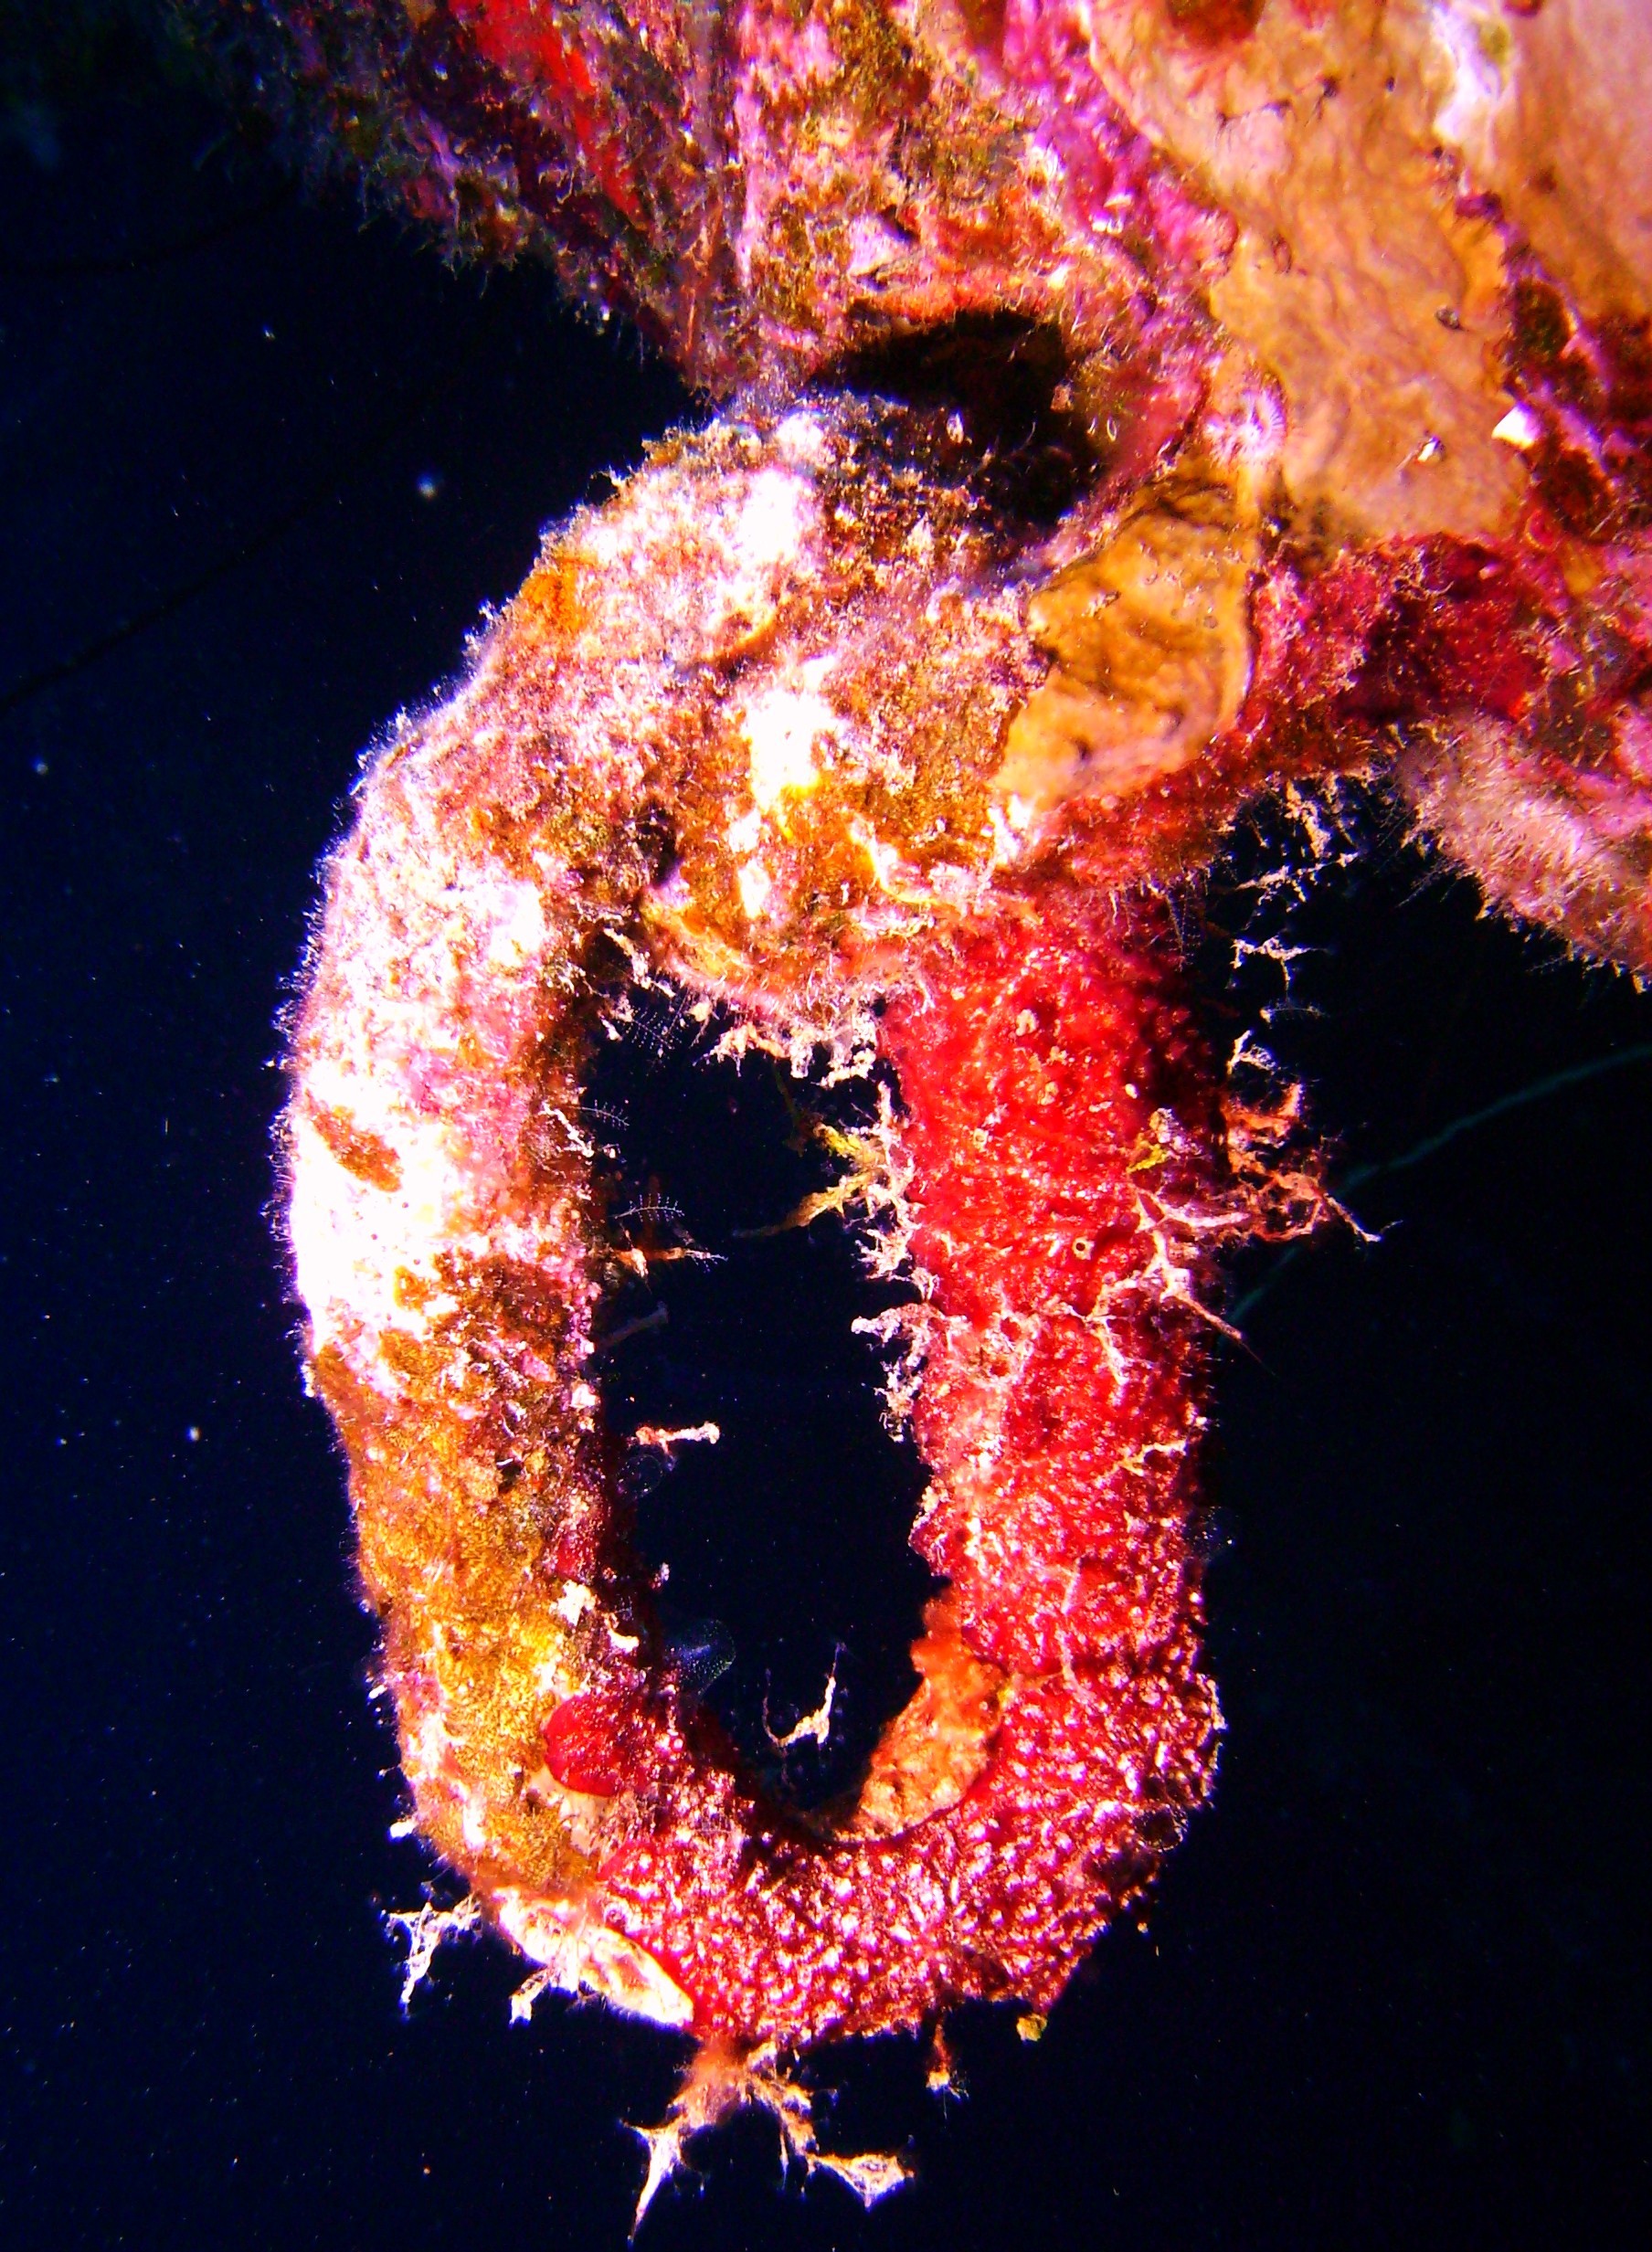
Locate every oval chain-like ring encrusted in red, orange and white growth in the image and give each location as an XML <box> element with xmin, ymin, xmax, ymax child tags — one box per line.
<box><xmin>289</xmin><ymin>403</ymin><xmax>1253</xmax><ymax>2049</ymax></box>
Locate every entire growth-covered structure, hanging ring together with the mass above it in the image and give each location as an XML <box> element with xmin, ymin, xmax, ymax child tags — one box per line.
<box><xmin>235</xmin><ymin>0</ymin><xmax>1652</xmax><ymax>2203</ymax></box>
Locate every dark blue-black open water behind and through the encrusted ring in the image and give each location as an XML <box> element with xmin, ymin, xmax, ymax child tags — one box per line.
<box><xmin>0</xmin><ymin>39</ymin><xmax>1652</xmax><ymax>2252</ymax></box>
